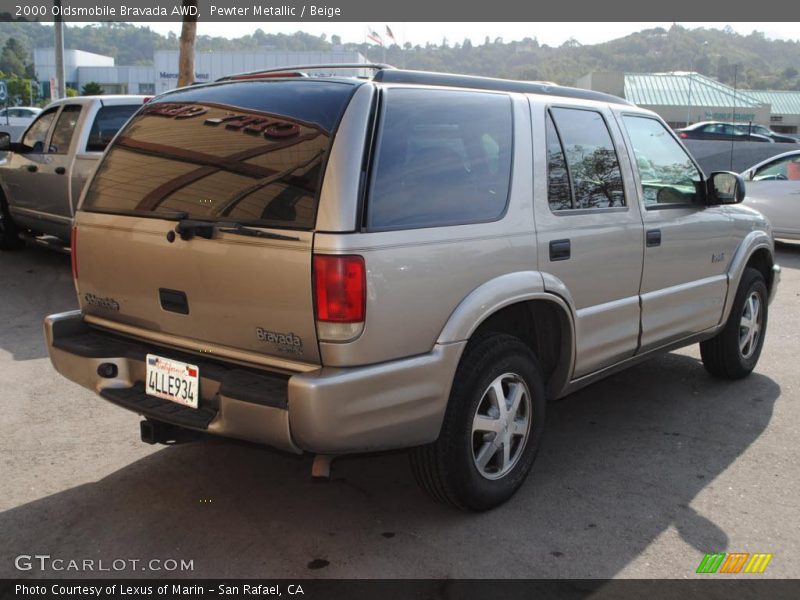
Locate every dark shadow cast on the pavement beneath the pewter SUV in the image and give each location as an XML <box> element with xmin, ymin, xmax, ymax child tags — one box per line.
<box><xmin>0</xmin><ymin>354</ymin><xmax>780</xmax><ymax>578</ymax></box>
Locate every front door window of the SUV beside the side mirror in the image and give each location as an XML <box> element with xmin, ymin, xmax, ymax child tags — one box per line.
<box><xmin>624</xmin><ymin>116</ymin><xmax>702</xmax><ymax>207</ymax></box>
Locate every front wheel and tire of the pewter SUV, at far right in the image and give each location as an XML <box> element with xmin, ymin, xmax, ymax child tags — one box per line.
<box><xmin>700</xmin><ymin>268</ymin><xmax>769</xmax><ymax>379</ymax></box>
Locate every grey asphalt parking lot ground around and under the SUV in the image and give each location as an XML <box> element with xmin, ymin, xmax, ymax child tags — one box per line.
<box><xmin>0</xmin><ymin>244</ymin><xmax>800</xmax><ymax>578</ymax></box>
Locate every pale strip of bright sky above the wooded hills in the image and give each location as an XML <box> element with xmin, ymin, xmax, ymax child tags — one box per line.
<box><xmin>139</xmin><ymin>21</ymin><xmax>800</xmax><ymax>46</ymax></box>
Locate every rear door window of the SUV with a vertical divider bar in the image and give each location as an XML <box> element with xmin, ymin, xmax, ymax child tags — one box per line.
<box><xmin>545</xmin><ymin>108</ymin><xmax>625</xmax><ymax>210</ymax></box>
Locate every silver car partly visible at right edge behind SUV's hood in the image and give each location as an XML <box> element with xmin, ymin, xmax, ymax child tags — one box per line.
<box><xmin>742</xmin><ymin>150</ymin><xmax>800</xmax><ymax>240</ymax></box>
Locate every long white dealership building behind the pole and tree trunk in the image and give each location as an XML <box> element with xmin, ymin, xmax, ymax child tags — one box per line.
<box><xmin>33</xmin><ymin>48</ymin><xmax>368</xmax><ymax>97</ymax></box>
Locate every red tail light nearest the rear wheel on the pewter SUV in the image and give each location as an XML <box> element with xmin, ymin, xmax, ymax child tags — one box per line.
<box><xmin>313</xmin><ymin>254</ymin><xmax>367</xmax><ymax>342</ymax></box>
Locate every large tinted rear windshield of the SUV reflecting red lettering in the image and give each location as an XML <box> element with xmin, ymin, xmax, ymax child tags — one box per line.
<box><xmin>83</xmin><ymin>80</ymin><xmax>354</xmax><ymax>229</ymax></box>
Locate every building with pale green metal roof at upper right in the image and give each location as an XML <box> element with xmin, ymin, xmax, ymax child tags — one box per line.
<box><xmin>577</xmin><ymin>71</ymin><xmax>800</xmax><ymax>134</ymax></box>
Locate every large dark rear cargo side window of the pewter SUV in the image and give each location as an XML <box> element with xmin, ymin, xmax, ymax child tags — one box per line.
<box><xmin>366</xmin><ymin>89</ymin><xmax>513</xmax><ymax>231</ymax></box>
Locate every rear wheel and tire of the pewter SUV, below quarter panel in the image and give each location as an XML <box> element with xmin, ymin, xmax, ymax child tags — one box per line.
<box><xmin>411</xmin><ymin>333</ymin><xmax>546</xmax><ymax>511</ymax></box>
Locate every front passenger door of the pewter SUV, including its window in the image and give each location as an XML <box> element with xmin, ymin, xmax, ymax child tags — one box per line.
<box><xmin>622</xmin><ymin>114</ymin><xmax>736</xmax><ymax>352</ymax></box>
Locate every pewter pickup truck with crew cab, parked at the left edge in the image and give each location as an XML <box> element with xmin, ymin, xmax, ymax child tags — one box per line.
<box><xmin>0</xmin><ymin>96</ymin><xmax>145</xmax><ymax>249</ymax></box>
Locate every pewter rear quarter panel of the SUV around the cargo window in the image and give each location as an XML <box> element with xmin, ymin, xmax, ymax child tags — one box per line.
<box><xmin>314</xmin><ymin>96</ymin><xmax>537</xmax><ymax>366</ymax></box>
